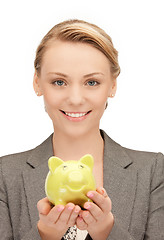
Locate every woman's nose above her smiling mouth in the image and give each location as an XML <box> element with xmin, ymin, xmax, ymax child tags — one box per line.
<box><xmin>68</xmin><ymin>86</ymin><xmax>85</xmax><ymax>105</ymax></box>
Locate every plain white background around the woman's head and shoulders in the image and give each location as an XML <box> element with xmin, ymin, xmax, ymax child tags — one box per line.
<box><xmin>0</xmin><ymin>0</ymin><xmax>164</xmax><ymax>156</ymax></box>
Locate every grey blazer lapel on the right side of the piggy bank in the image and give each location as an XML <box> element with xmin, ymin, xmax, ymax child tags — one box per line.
<box><xmin>102</xmin><ymin>132</ymin><xmax>138</xmax><ymax>229</ymax></box>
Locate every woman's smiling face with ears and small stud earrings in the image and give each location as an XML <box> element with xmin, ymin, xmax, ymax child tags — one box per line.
<box><xmin>34</xmin><ymin>41</ymin><xmax>116</xmax><ymax>136</ymax></box>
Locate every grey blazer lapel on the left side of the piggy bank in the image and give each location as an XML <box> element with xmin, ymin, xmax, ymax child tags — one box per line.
<box><xmin>23</xmin><ymin>135</ymin><xmax>53</xmax><ymax>224</ymax></box>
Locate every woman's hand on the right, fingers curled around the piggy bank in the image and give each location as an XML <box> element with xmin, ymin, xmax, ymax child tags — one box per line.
<box><xmin>76</xmin><ymin>188</ymin><xmax>114</xmax><ymax>240</ymax></box>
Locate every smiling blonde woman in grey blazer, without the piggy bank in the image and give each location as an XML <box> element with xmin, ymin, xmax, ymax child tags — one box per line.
<box><xmin>0</xmin><ymin>20</ymin><xmax>164</xmax><ymax>240</ymax></box>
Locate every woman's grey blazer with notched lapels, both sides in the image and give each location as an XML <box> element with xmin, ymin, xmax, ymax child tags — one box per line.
<box><xmin>0</xmin><ymin>131</ymin><xmax>164</xmax><ymax>240</ymax></box>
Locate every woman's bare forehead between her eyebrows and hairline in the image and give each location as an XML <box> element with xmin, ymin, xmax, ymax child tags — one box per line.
<box><xmin>42</xmin><ymin>40</ymin><xmax>110</xmax><ymax>75</ymax></box>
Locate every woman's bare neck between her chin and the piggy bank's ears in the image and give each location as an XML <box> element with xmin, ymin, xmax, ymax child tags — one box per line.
<box><xmin>53</xmin><ymin>129</ymin><xmax>104</xmax><ymax>161</ymax></box>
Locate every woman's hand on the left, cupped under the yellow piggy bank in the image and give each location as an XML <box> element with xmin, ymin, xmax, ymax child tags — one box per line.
<box><xmin>37</xmin><ymin>198</ymin><xmax>81</xmax><ymax>240</ymax></box>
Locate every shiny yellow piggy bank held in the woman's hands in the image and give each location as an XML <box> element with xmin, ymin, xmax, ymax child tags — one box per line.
<box><xmin>45</xmin><ymin>154</ymin><xmax>96</xmax><ymax>207</ymax></box>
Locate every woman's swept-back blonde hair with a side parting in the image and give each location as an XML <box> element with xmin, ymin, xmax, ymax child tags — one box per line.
<box><xmin>34</xmin><ymin>19</ymin><xmax>120</xmax><ymax>78</ymax></box>
